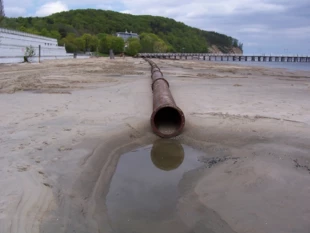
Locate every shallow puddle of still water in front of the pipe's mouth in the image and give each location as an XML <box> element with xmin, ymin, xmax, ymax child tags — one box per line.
<box><xmin>106</xmin><ymin>140</ymin><xmax>205</xmax><ymax>233</ymax></box>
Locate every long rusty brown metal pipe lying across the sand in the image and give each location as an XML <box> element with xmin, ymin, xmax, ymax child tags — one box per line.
<box><xmin>144</xmin><ymin>58</ymin><xmax>185</xmax><ymax>138</ymax></box>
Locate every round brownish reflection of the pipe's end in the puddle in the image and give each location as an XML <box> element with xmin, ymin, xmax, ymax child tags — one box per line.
<box><xmin>151</xmin><ymin>139</ymin><xmax>184</xmax><ymax>171</ymax></box>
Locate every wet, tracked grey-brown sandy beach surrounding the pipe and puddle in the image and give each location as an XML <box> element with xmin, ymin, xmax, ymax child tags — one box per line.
<box><xmin>0</xmin><ymin>58</ymin><xmax>310</xmax><ymax>233</ymax></box>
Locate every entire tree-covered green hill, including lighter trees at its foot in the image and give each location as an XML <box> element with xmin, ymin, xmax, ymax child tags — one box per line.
<box><xmin>2</xmin><ymin>9</ymin><xmax>242</xmax><ymax>53</ymax></box>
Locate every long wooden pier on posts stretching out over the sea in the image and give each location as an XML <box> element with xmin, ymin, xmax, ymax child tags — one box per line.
<box><xmin>138</xmin><ymin>53</ymin><xmax>310</xmax><ymax>62</ymax></box>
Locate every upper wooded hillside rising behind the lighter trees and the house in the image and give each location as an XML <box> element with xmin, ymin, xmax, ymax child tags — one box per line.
<box><xmin>1</xmin><ymin>9</ymin><xmax>242</xmax><ymax>52</ymax></box>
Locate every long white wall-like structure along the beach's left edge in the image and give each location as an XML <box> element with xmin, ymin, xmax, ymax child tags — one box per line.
<box><xmin>0</xmin><ymin>28</ymin><xmax>73</xmax><ymax>63</ymax></box>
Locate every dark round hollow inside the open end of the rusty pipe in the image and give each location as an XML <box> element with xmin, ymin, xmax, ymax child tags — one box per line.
<box><xmin>154</xmin><ymin>107</ymin><xmax>182</xmax><ymax>135</ymax></box>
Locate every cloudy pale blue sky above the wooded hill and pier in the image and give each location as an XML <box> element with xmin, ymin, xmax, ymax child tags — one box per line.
<box><xmin>3</xmin><ymin>0</ymin><xmax>310</xmax><ymax>54</ymax></box>
